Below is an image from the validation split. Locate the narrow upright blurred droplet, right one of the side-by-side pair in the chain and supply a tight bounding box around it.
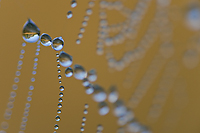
[108,86,119,103]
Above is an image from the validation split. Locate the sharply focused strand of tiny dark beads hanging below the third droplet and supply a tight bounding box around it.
[54,53,64,133]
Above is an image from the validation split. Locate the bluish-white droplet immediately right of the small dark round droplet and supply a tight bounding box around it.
[74,65,87,80]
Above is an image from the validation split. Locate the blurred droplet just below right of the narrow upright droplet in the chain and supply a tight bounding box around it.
[114,100,127,117]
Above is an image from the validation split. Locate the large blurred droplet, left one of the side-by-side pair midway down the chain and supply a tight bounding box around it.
[93,84,106,102]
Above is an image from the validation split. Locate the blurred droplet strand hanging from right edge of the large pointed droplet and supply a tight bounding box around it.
[19,41,40,133]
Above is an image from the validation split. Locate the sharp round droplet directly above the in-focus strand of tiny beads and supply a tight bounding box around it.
[51,37,64,51]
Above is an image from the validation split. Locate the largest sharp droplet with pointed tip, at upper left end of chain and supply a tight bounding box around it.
[22,19,40,43]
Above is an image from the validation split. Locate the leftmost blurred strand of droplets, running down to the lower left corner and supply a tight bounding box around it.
[0,43,26,133]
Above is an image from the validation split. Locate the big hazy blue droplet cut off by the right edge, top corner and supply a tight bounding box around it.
[185,2,200,30]
